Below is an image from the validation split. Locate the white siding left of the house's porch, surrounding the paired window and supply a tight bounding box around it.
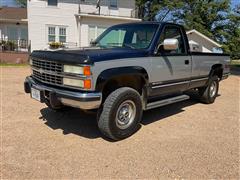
[28,0,79,50]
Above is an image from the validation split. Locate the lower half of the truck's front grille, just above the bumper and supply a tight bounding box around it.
[33,70,63,85]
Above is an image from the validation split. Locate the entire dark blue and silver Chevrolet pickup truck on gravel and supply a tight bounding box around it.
[24,22,230,140]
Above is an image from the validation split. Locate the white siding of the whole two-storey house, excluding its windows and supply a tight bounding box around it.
[28,0,138,50]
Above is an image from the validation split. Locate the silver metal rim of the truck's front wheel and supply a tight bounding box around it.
[116,100,136,129]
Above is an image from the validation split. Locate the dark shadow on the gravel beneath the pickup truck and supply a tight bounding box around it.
[39,92,203,141]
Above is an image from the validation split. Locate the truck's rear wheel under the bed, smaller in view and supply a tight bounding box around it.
[198,76,219,104]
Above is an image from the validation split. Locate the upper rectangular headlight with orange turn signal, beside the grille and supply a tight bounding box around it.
[63,65,91,76]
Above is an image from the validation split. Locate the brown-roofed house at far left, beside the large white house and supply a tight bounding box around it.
[0,7,28,49]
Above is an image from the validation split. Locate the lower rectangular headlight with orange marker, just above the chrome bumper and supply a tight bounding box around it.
[63,78,92,89]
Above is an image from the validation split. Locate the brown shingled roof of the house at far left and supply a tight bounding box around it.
[0,7,27,22]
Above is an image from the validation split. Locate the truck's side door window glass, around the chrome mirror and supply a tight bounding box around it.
[158,26,186,54]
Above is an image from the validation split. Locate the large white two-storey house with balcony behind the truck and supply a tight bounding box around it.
[28,0,140,50]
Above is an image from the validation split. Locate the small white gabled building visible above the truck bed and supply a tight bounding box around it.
[187,29,222,53]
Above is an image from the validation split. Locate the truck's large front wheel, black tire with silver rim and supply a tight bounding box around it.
[98,87,142,140]
